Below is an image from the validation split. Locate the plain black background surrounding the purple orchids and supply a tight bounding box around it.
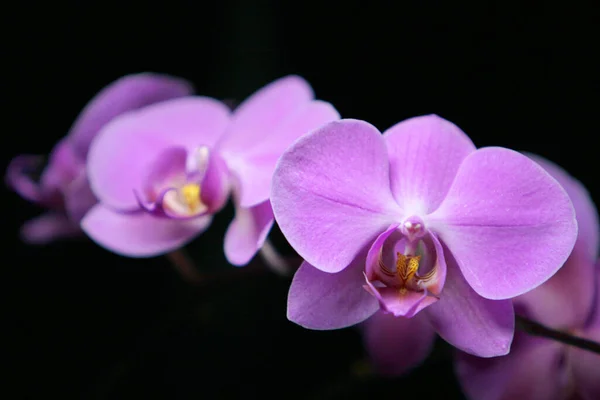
[0,0,600,399]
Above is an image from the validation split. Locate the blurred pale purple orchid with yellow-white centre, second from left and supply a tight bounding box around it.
[82,76,339,265]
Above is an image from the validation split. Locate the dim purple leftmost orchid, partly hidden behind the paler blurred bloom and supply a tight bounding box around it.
[6,73,193,244]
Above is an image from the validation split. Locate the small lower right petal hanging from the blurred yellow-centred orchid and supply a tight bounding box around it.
[225,201,273,266]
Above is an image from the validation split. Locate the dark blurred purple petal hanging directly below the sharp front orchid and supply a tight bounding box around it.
[361,311,435,376]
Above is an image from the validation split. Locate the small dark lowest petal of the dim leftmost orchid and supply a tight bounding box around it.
[21,212,82,245]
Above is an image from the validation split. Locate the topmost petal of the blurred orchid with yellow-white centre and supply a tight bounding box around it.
[218,75,314,154]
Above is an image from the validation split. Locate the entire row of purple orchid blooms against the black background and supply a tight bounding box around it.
[7,74,600,399]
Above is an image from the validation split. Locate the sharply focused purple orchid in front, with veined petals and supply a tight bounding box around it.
[271,116,577,357]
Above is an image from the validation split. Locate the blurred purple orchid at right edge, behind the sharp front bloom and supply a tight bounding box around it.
[456,156,600,400]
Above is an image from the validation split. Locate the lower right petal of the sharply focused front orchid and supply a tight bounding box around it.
[423,249,515,357]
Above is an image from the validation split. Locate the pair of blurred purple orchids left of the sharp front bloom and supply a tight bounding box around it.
[7,74,339,265]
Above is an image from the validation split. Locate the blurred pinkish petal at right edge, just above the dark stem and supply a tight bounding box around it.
[513,242,595,329]
